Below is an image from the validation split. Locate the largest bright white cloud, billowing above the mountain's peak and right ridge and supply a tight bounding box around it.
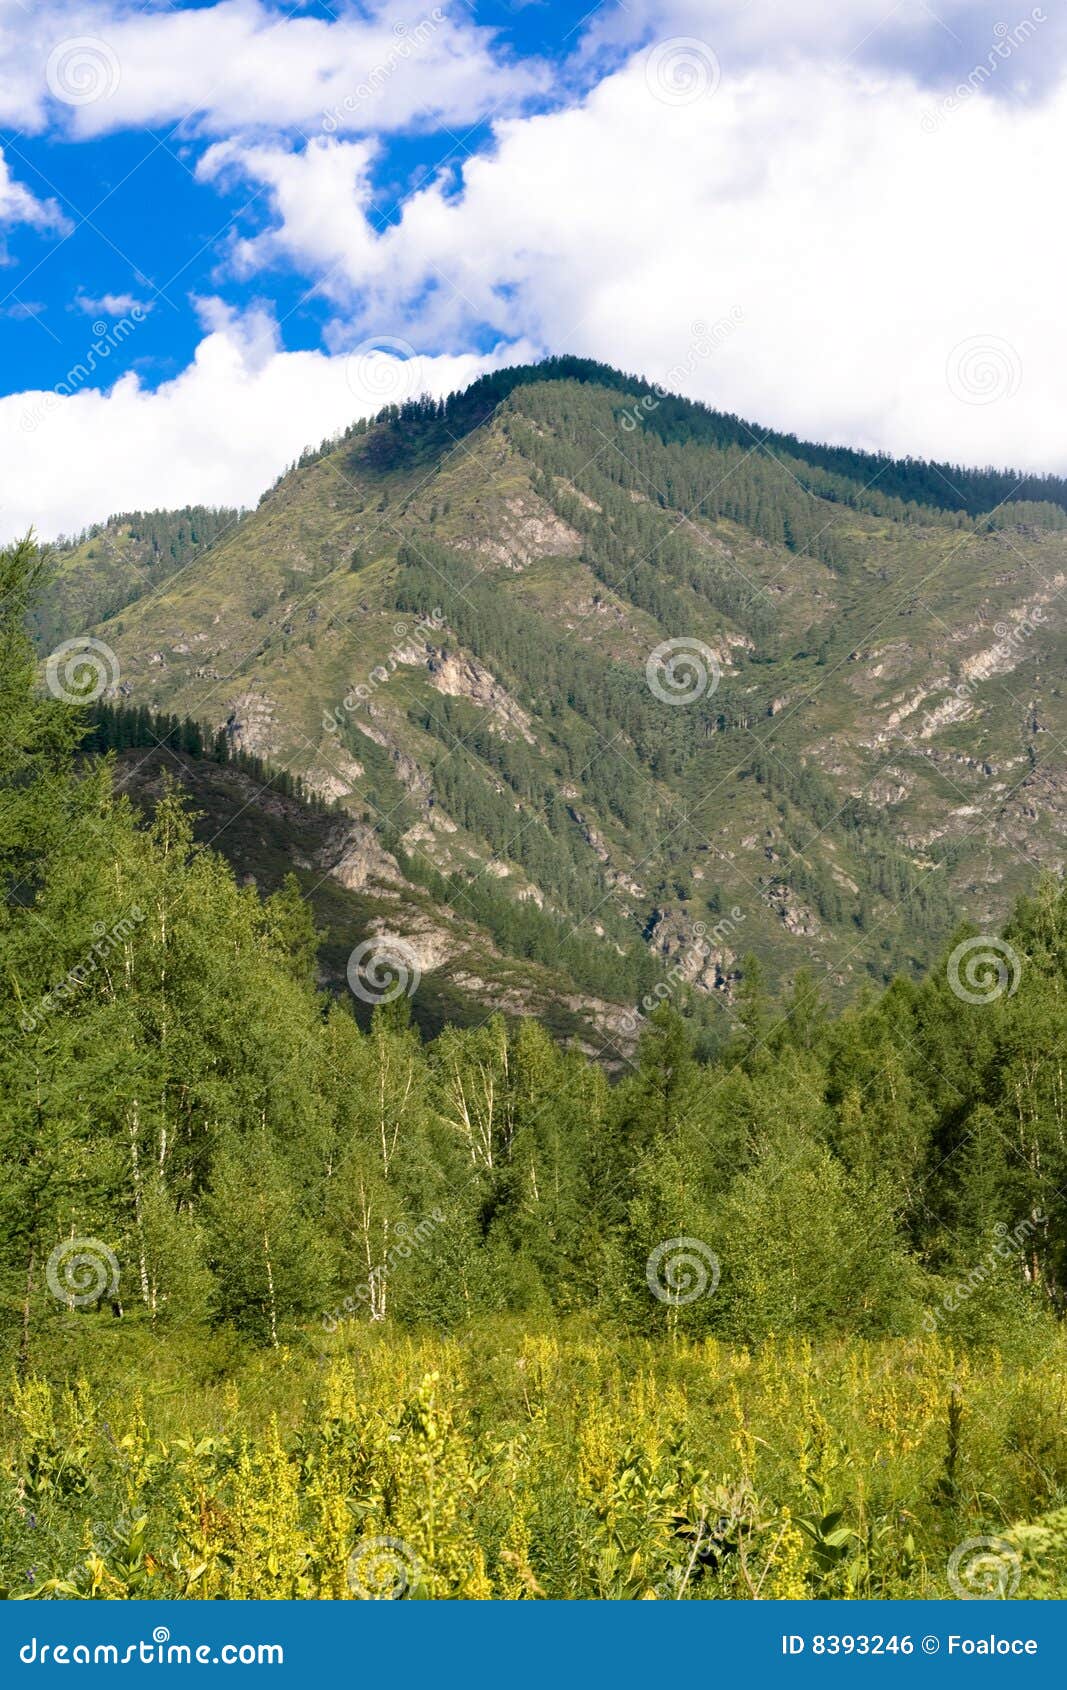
[203,42,1067,468]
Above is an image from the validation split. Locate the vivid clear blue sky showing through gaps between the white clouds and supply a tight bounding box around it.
[0,0,617,394]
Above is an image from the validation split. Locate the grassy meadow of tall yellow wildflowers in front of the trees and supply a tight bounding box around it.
[0,1317,1067,1600]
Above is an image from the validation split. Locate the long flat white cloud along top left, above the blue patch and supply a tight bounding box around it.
[0,0,548,137]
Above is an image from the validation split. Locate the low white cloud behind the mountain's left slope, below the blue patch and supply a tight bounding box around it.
[0,301,530,541]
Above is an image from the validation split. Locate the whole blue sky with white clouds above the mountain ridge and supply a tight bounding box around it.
[0,0,1067,536]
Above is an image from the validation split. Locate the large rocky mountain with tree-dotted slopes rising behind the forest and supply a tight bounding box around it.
[39,360,1067,1043]
